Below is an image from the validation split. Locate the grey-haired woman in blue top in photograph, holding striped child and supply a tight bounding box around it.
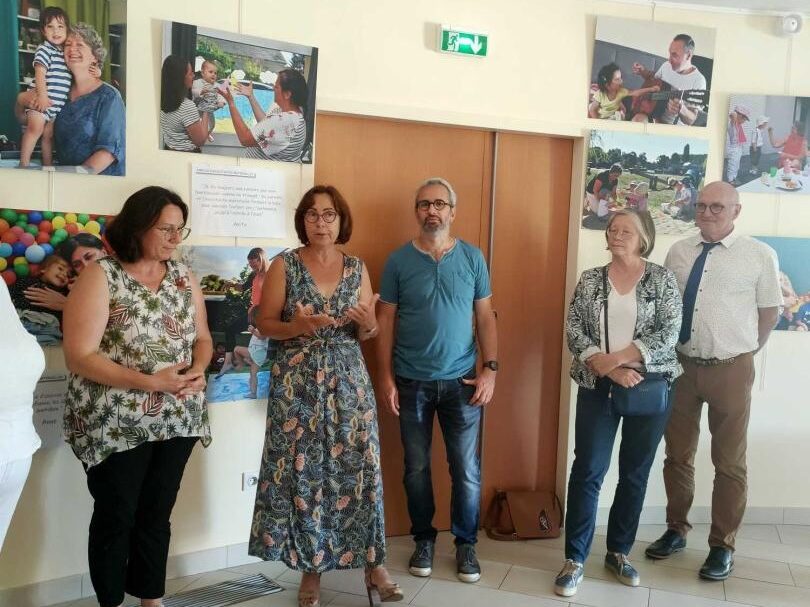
[53,23,126,175]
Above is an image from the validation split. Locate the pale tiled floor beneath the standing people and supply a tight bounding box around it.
[52,525,810,607]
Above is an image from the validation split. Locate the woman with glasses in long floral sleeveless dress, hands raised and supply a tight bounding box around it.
[250,186,403,607]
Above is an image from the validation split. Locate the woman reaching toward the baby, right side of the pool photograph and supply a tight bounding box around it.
[222,69,309,162]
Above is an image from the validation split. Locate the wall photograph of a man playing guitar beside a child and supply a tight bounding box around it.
[588,17,715,126]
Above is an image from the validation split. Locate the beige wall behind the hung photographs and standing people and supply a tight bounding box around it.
[0,0,810,588]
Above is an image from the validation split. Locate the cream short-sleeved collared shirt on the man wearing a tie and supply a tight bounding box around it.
[664,231,782,359]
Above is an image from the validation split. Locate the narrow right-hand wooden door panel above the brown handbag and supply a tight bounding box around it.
[482,133,573,505]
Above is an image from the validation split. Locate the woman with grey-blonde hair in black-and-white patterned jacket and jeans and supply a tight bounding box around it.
[554,209,682,596]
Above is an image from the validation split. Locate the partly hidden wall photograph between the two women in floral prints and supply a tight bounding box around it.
[180,245,284,403]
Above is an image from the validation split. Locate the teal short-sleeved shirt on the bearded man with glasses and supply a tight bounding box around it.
[380,239,492,381]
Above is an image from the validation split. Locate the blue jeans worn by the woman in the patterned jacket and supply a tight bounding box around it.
[565,379,672,563]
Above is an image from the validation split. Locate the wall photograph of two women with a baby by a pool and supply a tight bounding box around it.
[159,22,318,163]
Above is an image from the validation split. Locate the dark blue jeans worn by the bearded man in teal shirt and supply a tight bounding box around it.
[396,370,481,544]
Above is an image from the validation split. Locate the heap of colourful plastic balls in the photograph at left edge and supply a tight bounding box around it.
[0,209,112,287]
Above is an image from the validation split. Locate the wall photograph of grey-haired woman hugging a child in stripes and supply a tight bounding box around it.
[0,0,127,176]
